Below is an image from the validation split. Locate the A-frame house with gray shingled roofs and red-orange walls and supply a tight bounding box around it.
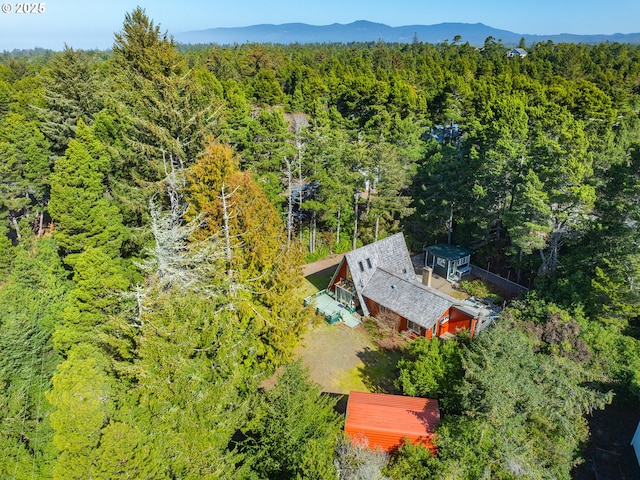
[327,233,479,338]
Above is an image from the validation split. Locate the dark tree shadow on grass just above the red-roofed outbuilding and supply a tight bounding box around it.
[357,347,402,394]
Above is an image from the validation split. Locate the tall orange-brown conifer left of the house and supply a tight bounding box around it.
[187,142,304,362]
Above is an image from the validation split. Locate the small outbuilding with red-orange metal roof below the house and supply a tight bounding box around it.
[344,392,440,452]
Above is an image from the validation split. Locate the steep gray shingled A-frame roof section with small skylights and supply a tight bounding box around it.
[344,233,415,315]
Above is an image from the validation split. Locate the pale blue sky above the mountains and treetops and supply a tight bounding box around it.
[0,0,640,51]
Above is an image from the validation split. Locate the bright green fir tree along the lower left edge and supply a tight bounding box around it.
[0,238,70,479]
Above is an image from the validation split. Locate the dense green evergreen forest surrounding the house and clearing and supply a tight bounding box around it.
[0,9,640,479]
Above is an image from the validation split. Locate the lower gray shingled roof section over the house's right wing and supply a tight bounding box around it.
[363,268,456,329]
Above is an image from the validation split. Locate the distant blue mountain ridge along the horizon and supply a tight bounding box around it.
[174,20,640,46]
